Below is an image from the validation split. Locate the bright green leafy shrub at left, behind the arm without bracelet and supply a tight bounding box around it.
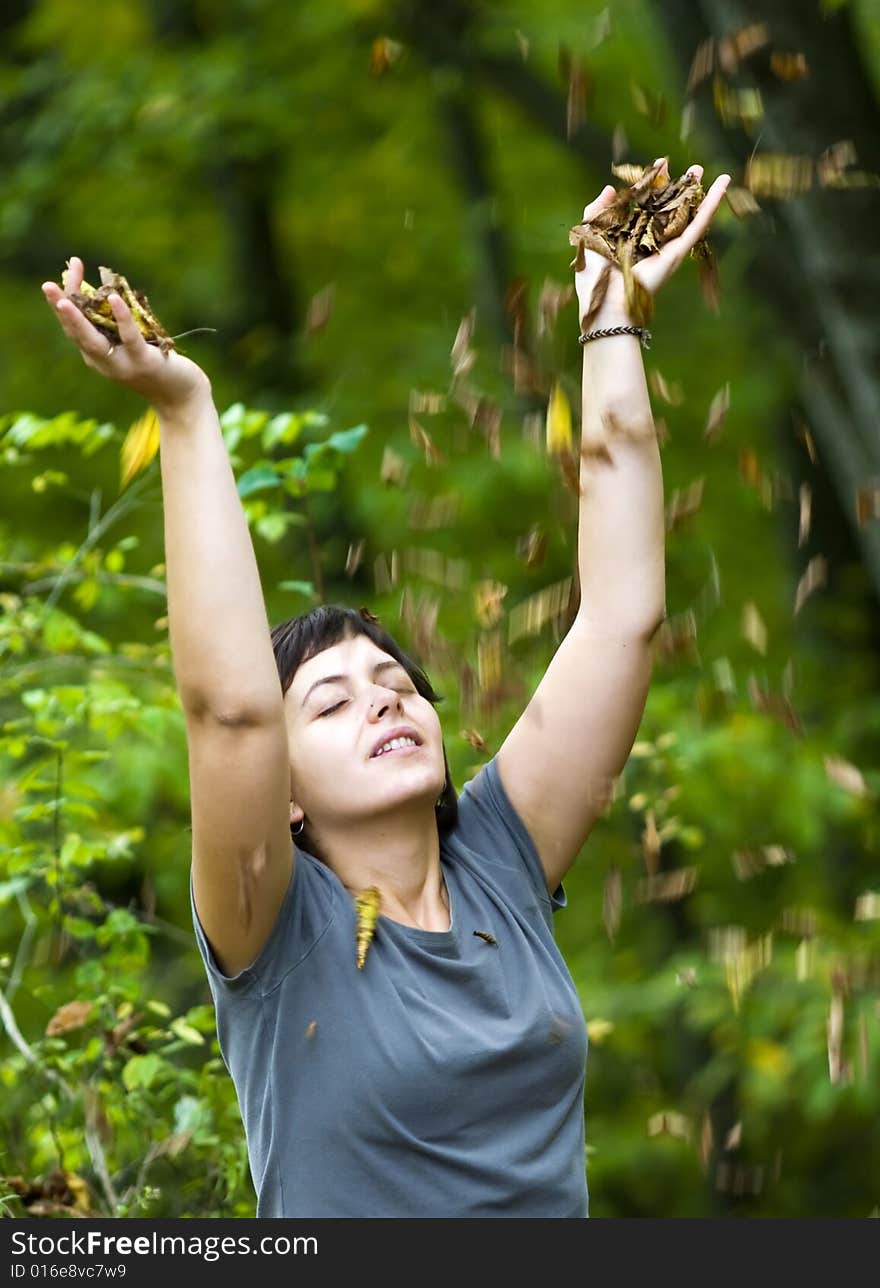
[0,404,367,1216]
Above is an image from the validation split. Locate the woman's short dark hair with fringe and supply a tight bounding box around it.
[272,604,459,858]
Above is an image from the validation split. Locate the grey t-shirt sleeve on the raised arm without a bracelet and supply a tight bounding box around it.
[189,842,334,993]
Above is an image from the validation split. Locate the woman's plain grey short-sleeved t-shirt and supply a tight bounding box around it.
[189,760,588,1217]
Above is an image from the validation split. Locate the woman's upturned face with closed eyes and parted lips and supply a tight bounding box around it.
[285,635,446,832]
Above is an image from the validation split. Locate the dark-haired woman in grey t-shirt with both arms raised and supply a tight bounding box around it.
[43,167,728,1217]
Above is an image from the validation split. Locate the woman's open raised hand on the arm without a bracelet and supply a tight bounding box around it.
[43,255,211,416]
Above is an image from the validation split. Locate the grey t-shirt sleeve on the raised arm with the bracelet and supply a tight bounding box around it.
[455,756,568,912]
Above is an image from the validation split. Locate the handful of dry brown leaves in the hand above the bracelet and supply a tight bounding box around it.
[568,157,718,326]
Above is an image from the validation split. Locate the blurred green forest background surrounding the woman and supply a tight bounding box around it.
[0,0,880,1217]
